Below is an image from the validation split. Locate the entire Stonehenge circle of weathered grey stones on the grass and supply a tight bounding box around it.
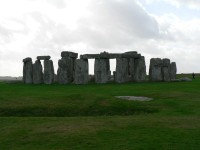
[23,51,177,84]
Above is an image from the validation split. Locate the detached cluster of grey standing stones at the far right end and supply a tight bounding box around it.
[149,58,177,81]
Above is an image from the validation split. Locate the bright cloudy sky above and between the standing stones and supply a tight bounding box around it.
[0,0,200,76]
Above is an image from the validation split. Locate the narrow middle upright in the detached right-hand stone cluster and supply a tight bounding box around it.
[162,58,170,81]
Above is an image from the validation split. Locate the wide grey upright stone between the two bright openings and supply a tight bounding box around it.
[94,59,111,83]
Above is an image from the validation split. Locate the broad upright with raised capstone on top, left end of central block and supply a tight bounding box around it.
[57,51,78,84]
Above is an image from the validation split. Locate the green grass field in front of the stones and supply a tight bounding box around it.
[0,77,200,150]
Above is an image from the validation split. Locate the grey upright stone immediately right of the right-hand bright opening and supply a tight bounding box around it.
[115,58,129,83]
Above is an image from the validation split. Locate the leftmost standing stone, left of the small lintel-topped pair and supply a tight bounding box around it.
[23,57,33,84]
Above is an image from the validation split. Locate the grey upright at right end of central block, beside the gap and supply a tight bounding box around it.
[134,56,146,82]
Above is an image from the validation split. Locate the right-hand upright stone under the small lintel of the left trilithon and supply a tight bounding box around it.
[43,60,54,84]
